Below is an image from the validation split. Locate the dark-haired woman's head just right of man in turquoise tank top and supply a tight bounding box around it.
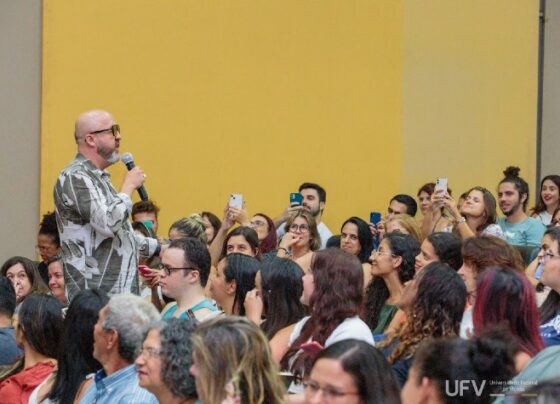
[209,253,261,316]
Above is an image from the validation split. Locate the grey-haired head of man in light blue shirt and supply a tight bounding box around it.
[93,294,160,365]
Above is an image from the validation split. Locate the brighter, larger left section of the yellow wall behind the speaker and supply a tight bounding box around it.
[41,0,403,231]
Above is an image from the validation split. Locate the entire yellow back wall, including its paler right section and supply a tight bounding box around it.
[41,0,538,232]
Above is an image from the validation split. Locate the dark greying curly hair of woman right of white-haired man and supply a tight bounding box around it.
[159,318,197,399]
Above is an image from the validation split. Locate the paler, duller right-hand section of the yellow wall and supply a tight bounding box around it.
[401,0,539,199]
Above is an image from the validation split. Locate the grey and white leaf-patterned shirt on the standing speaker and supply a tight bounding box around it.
[54,154,157,301]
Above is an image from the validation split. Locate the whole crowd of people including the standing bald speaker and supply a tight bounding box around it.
[0,111,560,404]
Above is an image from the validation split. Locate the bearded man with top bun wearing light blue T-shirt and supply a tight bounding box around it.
[498,167,546,247]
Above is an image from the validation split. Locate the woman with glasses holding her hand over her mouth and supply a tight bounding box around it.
[277,209,326,272]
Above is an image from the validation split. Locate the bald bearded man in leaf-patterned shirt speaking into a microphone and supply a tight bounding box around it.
[54,110,160,301]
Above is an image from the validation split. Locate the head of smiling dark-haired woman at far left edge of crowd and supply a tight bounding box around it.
[0,256,49,304]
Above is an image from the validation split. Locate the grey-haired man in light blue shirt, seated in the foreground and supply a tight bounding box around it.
[76,294,160,404]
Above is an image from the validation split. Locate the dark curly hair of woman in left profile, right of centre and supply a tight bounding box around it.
[363,233,420,330]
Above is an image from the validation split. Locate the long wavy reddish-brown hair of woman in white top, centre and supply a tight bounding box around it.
[281,248,364,376]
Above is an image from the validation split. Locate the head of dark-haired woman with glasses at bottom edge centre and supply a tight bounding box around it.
[305,339,400,404]
